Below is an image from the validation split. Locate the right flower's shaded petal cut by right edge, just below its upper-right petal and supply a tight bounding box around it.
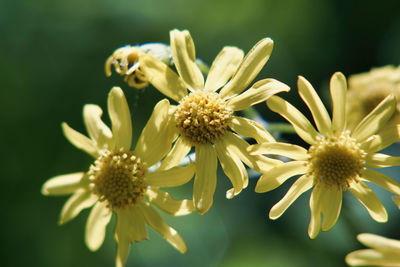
[361,125,400,152]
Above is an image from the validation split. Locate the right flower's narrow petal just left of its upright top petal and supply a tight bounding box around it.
[297,76,332,135]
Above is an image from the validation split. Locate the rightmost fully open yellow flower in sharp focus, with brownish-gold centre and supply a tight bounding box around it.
[249,73,400,238]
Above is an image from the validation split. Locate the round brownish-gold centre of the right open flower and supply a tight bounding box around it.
[308,132,366,190]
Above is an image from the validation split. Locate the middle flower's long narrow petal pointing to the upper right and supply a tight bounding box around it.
[220,38,274,98]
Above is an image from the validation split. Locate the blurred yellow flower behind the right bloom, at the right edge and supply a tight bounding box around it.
[346,65,400,131]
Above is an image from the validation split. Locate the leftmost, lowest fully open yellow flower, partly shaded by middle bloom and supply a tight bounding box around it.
[42,87,194,266]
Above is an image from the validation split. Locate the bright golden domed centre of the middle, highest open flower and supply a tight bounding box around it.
[175,90,233,144]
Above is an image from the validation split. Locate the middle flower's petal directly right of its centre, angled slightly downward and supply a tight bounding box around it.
[229,116,275,143]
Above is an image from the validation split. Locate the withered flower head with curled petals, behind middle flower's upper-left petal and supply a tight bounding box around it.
[105,43,171,89]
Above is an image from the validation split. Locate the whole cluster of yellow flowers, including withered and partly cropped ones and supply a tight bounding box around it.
[42,30,400,266]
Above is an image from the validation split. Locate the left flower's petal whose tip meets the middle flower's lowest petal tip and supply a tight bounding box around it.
[146,188,195,216]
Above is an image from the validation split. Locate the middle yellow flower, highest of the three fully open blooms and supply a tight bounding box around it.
[139,30,289,214]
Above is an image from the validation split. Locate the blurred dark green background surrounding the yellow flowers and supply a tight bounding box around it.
[0,0,400,267]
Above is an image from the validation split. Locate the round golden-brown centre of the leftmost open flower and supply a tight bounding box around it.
[89,149,147,210]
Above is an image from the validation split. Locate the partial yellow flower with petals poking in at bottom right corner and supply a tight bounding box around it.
[346,233,400,267]
